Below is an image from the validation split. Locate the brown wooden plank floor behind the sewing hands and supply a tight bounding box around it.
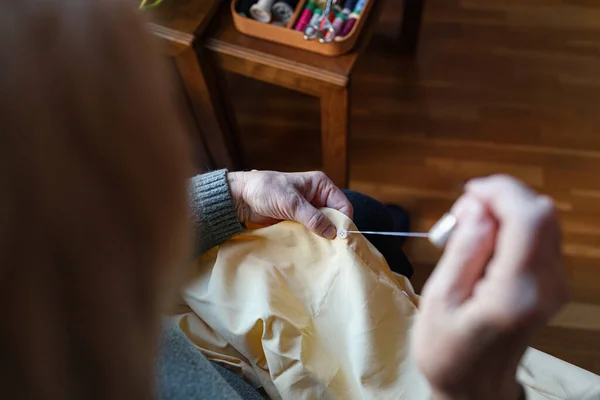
[225,0,600,374]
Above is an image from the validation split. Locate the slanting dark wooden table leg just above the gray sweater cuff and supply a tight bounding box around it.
[175,46,240,170]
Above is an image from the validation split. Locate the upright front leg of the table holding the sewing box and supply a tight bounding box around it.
[321,87,349,188]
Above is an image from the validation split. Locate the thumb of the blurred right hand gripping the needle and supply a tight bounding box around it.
[424,195,496,305]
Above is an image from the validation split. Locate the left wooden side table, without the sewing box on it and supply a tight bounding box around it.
[149,0,240,170]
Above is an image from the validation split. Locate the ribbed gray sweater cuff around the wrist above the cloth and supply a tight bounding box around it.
[189,169,243,255]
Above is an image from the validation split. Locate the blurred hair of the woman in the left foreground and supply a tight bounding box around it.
[0,0,191,399]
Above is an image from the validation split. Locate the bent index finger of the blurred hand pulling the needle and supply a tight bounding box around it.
[466,175,560,273]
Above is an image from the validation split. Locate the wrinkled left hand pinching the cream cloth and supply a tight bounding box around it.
[227,171,352,239]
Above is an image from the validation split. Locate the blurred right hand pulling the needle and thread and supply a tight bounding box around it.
[413,176,567,400]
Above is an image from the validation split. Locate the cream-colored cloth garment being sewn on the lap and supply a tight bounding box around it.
[174,210,600,400]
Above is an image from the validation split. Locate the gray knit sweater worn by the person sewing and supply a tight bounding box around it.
[157,170,262,400]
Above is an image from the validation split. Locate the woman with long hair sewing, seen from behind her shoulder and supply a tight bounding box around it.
[0,0,566,399]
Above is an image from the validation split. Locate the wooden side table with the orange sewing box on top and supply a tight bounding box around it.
[203,0,381,187]
